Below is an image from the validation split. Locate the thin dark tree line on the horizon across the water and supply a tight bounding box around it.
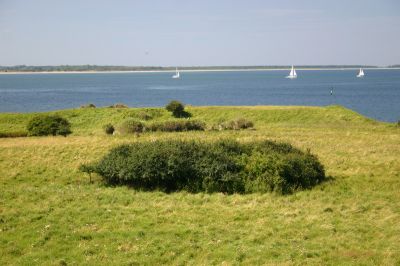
[0,65,388,72]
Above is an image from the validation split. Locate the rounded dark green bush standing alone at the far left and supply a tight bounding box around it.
[27,115,71,136]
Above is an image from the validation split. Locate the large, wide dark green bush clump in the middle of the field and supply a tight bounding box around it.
[81,140,325,194]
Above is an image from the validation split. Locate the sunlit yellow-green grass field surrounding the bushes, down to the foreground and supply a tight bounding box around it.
[0,106,400,265]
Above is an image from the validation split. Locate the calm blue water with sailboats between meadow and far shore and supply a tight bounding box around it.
[0,69,400,122]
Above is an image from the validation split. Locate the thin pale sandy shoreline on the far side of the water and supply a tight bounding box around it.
[0,67,400,75]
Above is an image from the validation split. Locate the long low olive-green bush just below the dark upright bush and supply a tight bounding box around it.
[146,120,205,132]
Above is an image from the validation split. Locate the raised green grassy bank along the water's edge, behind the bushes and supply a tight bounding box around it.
[0,106,384,136]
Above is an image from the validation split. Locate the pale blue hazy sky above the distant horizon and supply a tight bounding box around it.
[0,0,400,66]
